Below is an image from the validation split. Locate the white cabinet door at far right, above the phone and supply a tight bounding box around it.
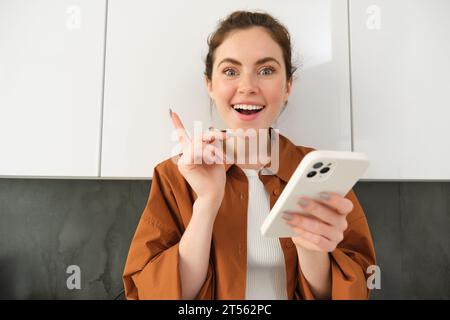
[350,0,450,180]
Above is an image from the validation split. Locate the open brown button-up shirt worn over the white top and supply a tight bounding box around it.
[123,134,375,300]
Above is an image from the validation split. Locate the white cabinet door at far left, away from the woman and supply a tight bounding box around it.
[0,0,106,177]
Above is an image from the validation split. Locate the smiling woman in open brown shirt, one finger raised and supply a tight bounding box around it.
[123,11,375,299]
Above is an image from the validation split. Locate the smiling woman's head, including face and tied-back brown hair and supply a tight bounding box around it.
[205,12,295,129]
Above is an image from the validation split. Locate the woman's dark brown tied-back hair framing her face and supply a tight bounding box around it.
[205,11,297,80]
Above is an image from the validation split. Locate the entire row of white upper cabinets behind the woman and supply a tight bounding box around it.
[0,0,450,180]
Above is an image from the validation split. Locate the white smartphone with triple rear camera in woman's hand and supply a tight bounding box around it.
[261,150,369,238]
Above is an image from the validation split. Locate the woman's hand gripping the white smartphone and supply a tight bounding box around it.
[283,192,353,252]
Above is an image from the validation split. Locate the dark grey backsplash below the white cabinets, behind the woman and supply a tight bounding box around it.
[0,179,450,299]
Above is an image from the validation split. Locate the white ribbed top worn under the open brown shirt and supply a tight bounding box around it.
[242,169,287,300]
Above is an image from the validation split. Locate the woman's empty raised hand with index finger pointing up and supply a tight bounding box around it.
[171,112,230,209]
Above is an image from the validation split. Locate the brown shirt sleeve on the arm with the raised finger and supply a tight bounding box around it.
[123,166,213,300]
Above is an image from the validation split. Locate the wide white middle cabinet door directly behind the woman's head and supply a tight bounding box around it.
[101,0,351,178]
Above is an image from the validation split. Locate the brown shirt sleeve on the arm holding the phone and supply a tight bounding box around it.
[299,190,376,300]
